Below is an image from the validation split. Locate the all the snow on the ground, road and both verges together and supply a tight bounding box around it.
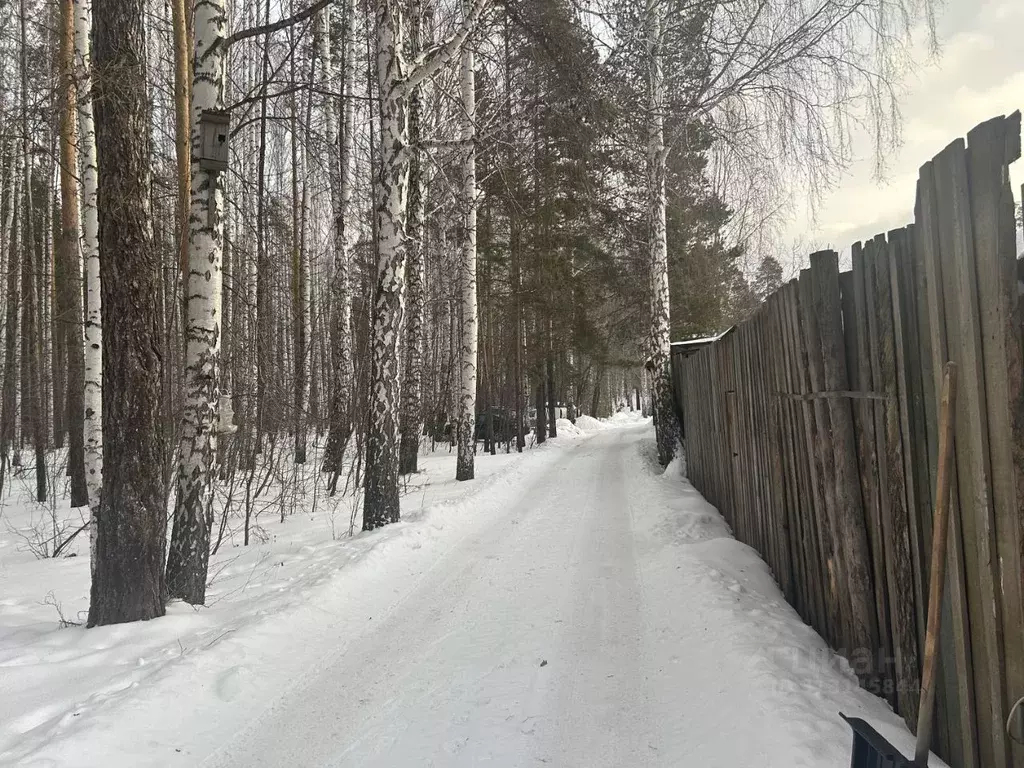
[0,415,934,768]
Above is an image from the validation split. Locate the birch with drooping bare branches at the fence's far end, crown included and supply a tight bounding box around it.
[597,0,933,464]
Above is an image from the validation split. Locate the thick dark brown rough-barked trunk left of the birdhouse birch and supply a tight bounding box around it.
[88,0,167,627]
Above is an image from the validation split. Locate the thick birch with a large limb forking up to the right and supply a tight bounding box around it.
[362,0,489,530]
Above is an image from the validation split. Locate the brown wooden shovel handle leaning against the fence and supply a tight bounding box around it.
[913,362,956,768]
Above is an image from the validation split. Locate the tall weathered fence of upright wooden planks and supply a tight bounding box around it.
[675,113,1024,768]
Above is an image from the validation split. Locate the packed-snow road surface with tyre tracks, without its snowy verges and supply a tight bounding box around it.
[209,423,675,768]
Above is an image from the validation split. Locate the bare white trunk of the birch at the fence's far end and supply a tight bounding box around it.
[647,0,679,466]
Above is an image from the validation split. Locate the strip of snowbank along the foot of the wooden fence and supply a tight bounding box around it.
[628,439,945,768]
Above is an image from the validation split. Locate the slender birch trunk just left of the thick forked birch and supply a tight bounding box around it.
[323,0,355,493]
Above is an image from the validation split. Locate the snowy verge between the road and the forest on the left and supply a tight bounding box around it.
[0,422,604,765]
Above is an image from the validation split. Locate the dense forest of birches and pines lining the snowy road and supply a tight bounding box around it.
[0,0,918,626]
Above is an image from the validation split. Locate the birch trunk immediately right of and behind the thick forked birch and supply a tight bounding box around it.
[398,0,430,474]
